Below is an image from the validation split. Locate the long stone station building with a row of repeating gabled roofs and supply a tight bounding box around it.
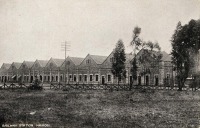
[0,50,175,85]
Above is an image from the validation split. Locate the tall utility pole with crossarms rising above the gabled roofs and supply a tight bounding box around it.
[61,41,70,86]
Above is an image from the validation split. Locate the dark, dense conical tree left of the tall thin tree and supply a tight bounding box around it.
[112,40,126,84]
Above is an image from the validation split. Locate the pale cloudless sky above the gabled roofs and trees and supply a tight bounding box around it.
[0,0,200,65]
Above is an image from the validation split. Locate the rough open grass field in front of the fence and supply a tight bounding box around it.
[0,89,200,128]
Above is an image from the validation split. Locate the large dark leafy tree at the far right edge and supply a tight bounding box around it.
[171,20,200,90]
